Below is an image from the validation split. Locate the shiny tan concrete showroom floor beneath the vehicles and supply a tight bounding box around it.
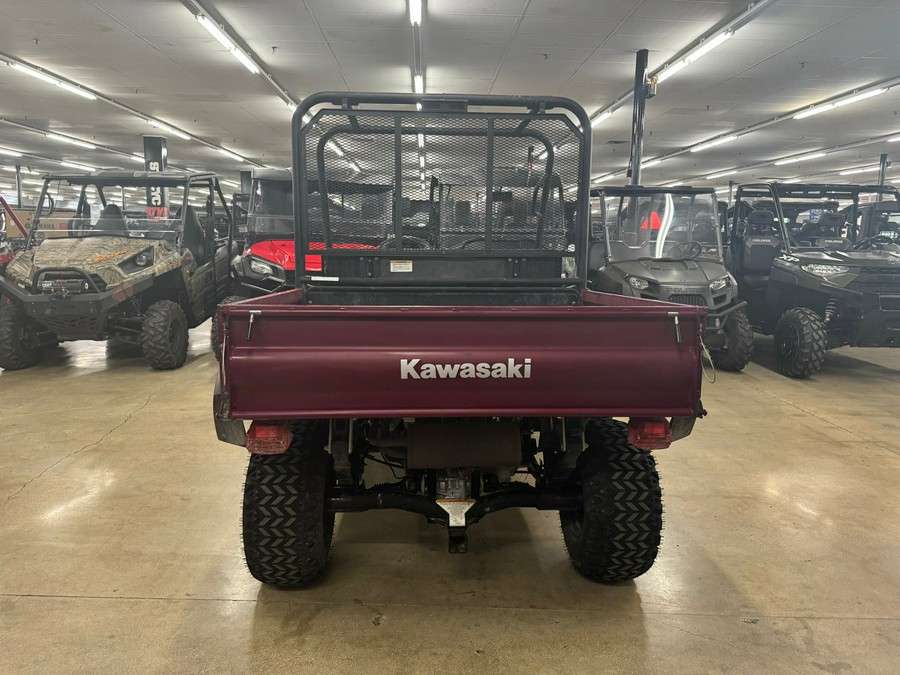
[0,326,900,673]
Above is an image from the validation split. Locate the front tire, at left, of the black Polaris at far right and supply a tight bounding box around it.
[775,307,827,379]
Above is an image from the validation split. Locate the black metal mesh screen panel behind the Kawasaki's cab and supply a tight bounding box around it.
[298,109,587,257]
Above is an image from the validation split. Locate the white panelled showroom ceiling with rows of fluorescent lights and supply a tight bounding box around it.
[0,0,900,195]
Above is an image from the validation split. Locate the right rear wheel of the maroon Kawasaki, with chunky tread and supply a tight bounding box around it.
[559,420,662,582]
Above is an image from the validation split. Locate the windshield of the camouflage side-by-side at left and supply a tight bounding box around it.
[32,179,220,243]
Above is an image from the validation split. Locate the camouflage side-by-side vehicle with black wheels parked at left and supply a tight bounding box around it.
[0,171,239,370]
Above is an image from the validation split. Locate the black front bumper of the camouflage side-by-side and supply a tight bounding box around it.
[0,277,153,341]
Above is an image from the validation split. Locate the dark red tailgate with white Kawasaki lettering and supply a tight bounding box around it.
[218,291,705,419]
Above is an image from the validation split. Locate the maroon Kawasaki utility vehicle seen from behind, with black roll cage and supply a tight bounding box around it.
[214,92,705,586]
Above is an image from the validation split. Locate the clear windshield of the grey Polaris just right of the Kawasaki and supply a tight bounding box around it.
[592,191,722,262]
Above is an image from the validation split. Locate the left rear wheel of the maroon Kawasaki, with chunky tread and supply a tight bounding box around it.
[243,423,334,586]
